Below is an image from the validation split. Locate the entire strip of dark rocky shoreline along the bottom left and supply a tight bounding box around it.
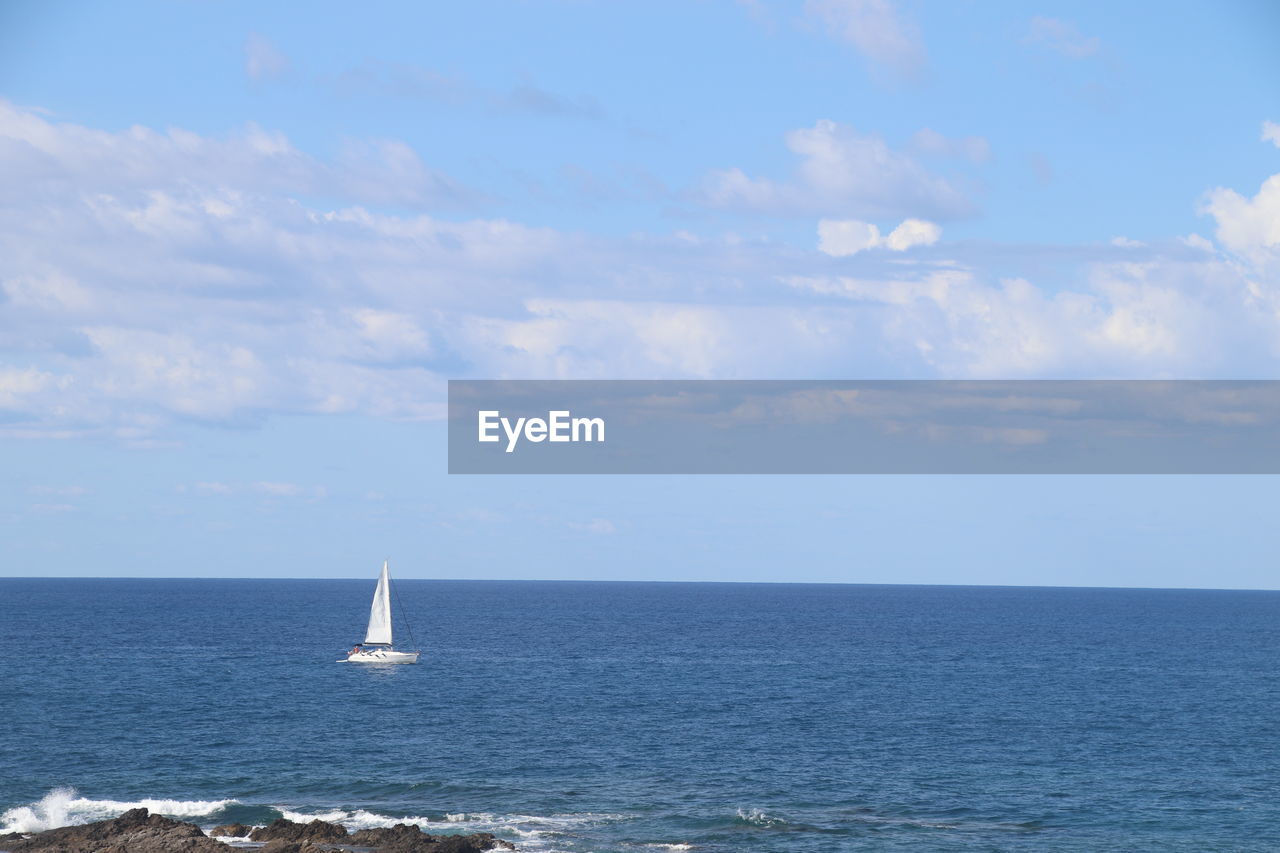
[0,808,516,853]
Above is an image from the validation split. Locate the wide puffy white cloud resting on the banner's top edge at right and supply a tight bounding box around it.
[787,233,1280,378]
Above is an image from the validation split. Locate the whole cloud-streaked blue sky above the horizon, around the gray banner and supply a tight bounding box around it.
[0,0,1280,588]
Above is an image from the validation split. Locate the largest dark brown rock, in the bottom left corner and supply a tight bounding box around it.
[5,808,228,853]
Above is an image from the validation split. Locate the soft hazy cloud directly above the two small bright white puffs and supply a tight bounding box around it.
[699,119,972,219]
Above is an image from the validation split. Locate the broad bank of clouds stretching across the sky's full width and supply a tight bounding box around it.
[0,104,1280,438]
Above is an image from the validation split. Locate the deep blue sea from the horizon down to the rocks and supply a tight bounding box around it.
[0,579,1280,853]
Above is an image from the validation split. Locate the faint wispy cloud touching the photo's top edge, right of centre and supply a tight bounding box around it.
[805,0,925,79]
